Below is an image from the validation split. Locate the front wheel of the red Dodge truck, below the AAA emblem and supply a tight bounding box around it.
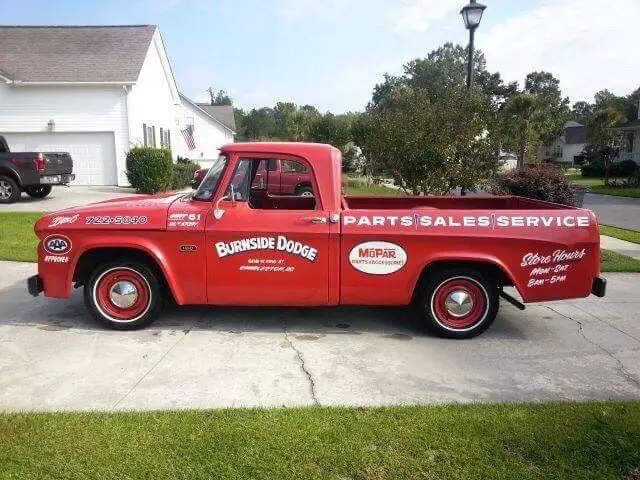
[84,261,162,330]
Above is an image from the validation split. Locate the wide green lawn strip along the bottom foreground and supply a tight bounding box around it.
[0,402,640,480]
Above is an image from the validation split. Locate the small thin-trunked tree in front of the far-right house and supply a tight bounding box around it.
[589,106,624,185]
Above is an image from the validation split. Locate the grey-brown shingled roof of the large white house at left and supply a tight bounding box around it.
[0,25,157,84]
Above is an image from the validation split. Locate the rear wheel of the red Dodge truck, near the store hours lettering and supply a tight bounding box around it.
[420,268,500,338]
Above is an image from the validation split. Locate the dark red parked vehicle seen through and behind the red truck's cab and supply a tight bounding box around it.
[191,159,313,197]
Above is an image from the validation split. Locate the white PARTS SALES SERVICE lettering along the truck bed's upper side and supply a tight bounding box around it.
[342,213,591,228]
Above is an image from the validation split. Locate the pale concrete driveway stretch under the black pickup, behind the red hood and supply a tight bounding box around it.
[0,186,135,212]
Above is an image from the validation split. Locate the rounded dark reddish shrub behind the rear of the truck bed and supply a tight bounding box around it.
[492,165,575,205]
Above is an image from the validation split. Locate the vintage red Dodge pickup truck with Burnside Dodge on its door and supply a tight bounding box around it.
[28,143,606,338]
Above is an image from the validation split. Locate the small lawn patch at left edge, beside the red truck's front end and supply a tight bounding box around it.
[0,212,42,262]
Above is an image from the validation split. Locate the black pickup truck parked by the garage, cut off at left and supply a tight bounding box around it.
[0,135,76,203]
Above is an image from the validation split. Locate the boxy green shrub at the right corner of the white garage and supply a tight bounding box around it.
[127,147,173,193]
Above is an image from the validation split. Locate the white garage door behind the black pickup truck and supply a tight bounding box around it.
[3,132,118,185]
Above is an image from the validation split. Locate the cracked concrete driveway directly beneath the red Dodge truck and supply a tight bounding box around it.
[0,262,640,410]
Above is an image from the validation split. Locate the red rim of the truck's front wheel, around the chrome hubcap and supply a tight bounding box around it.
[94,268,151,322]
